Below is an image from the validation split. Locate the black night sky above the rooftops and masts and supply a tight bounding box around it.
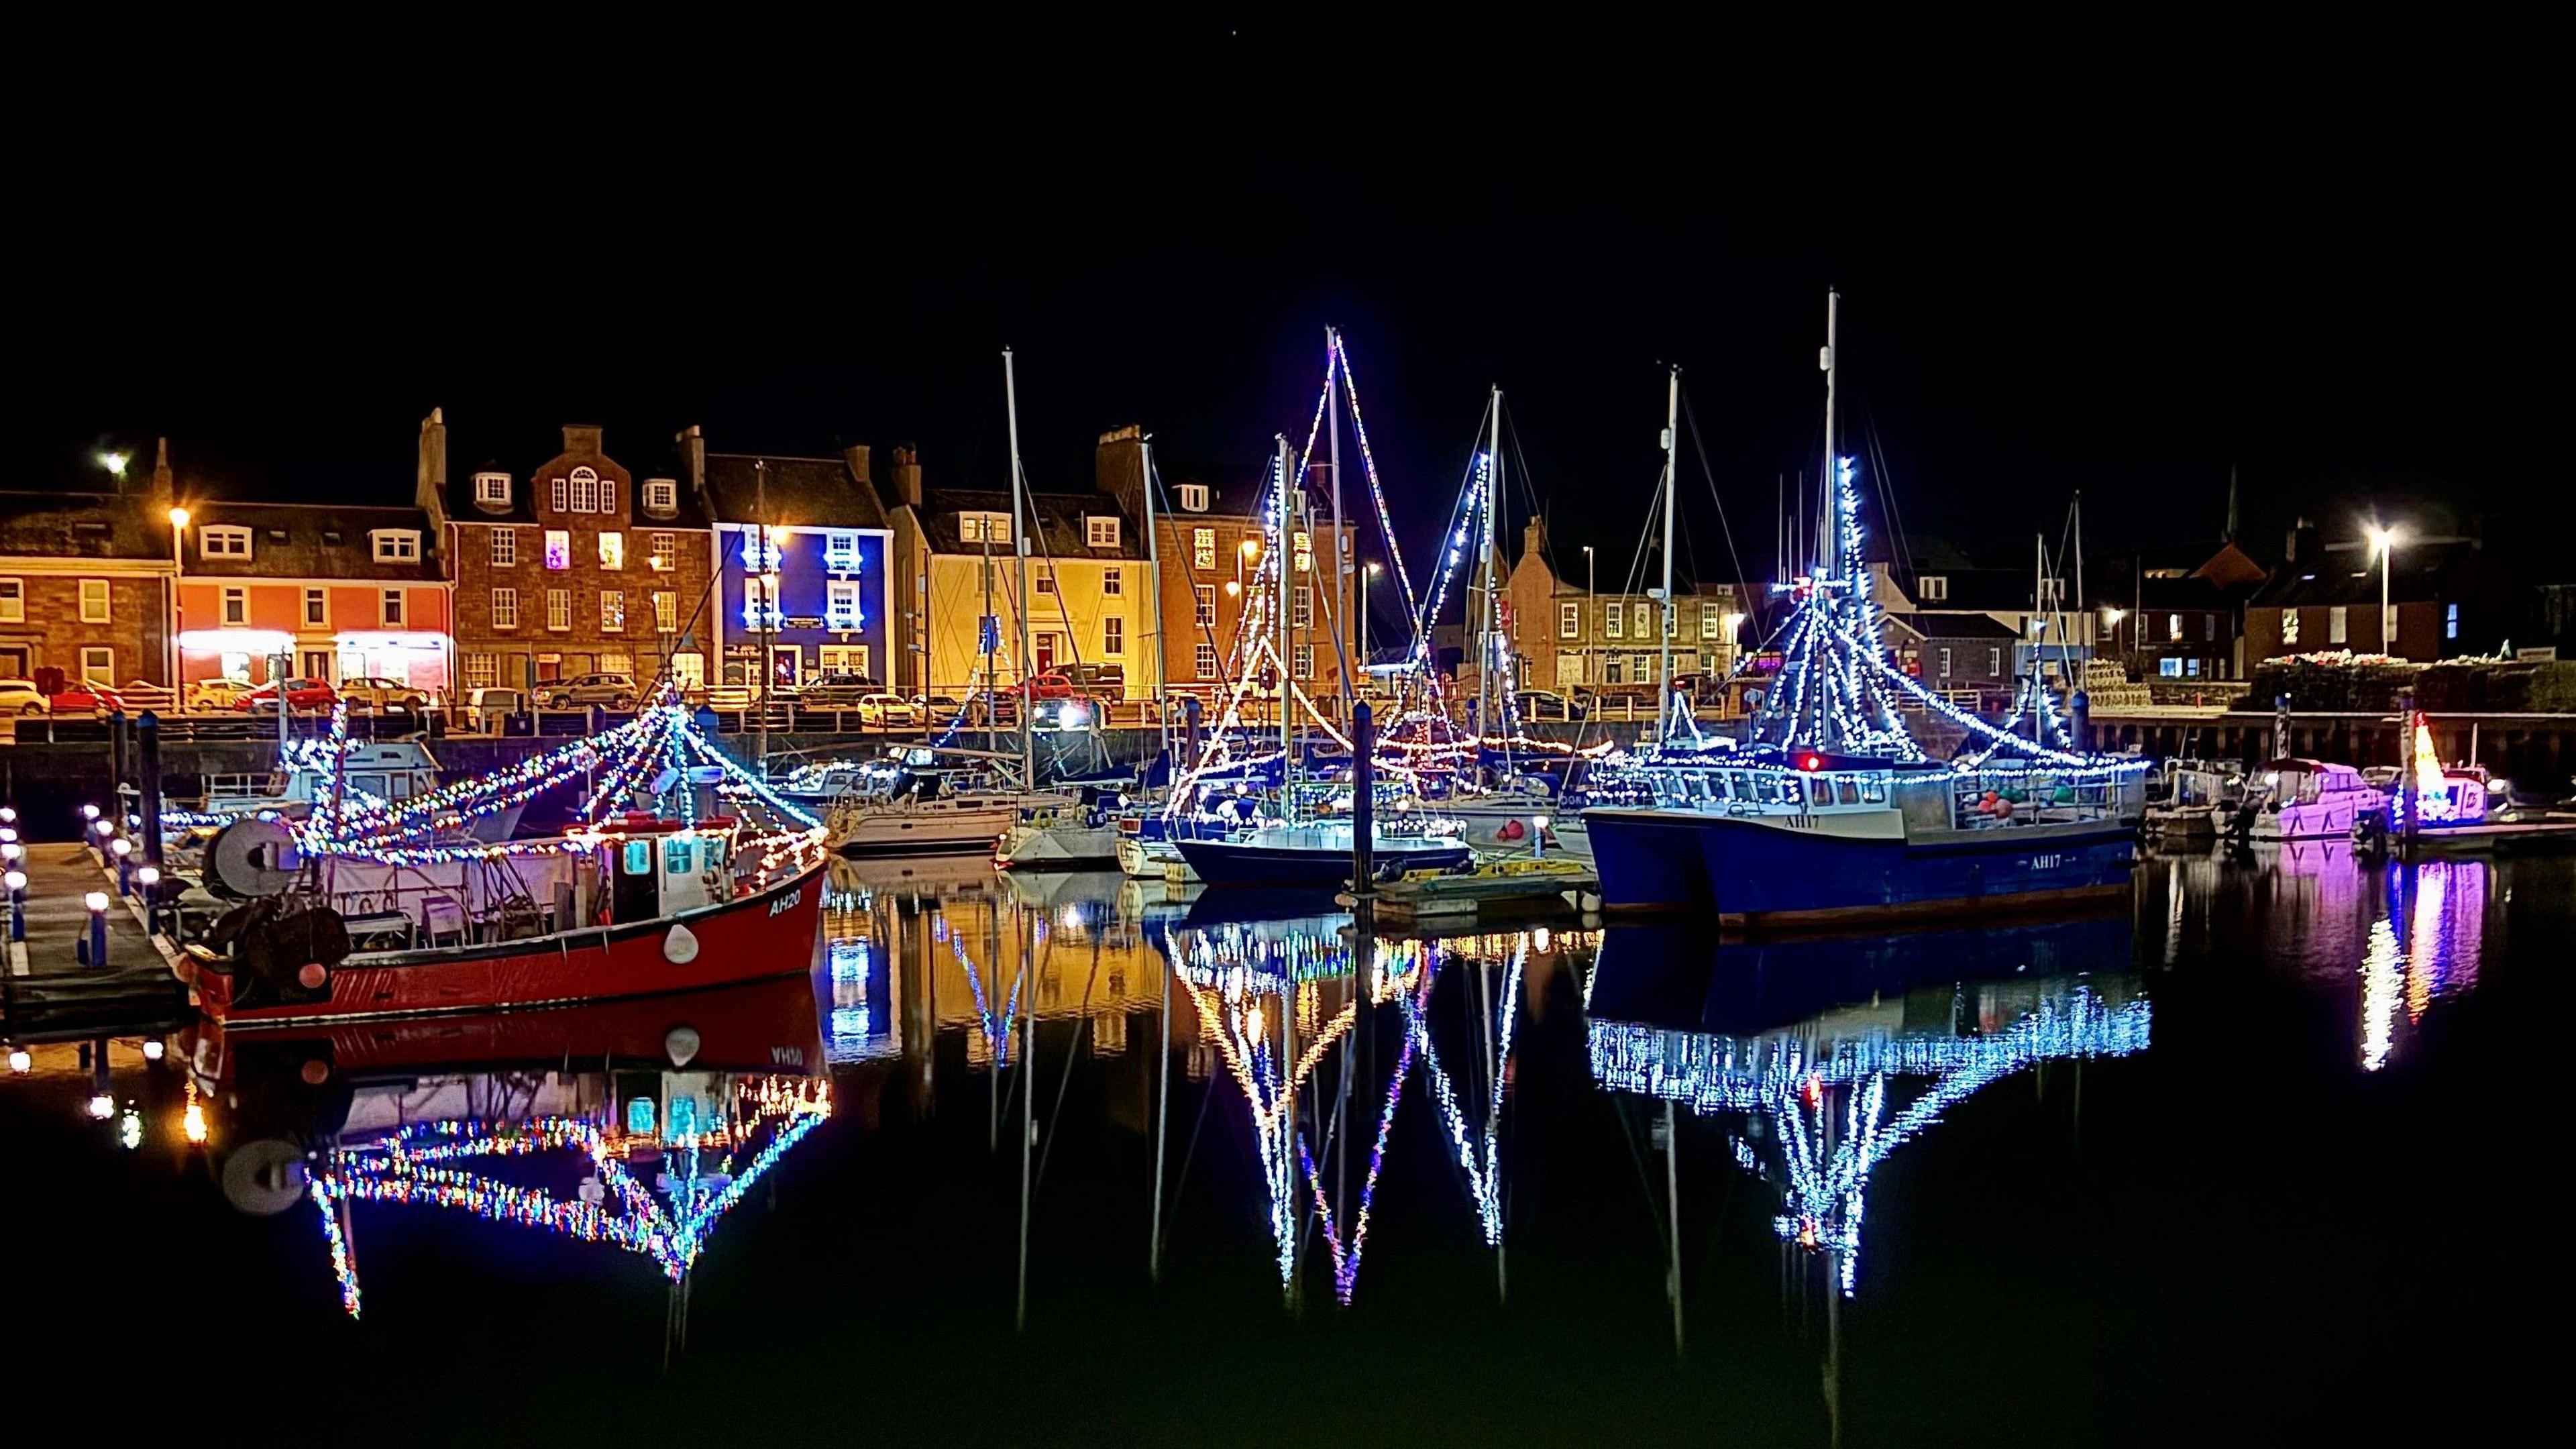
[25,34,2576,585]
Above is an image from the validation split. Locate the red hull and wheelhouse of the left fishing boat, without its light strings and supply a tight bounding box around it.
[178,822,824,1029]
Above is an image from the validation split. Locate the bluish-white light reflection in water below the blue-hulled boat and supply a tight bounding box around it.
[1589,982,2151,1297]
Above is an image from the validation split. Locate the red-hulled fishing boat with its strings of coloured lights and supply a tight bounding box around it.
[175,709,824,1031]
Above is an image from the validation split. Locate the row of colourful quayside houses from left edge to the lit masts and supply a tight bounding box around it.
[0,413,1355,699]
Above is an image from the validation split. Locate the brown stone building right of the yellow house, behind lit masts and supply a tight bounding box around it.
[1092,428,1386,704]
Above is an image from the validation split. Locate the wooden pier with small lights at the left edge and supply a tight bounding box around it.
[0,843,188,1042]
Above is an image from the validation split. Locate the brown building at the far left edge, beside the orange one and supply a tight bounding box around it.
[0,443,175,686]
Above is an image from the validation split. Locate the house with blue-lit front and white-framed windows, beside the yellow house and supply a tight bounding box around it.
[680,431,894,688]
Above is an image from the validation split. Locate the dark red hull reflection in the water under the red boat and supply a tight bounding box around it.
[191,977,824,1080]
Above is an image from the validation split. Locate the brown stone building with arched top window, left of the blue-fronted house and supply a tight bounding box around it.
[417,413,714,696]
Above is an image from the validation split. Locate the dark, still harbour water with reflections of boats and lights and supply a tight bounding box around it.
[0,848,2576,1444]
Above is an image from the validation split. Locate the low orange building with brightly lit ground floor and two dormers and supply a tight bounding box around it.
[178,502,453,696]
